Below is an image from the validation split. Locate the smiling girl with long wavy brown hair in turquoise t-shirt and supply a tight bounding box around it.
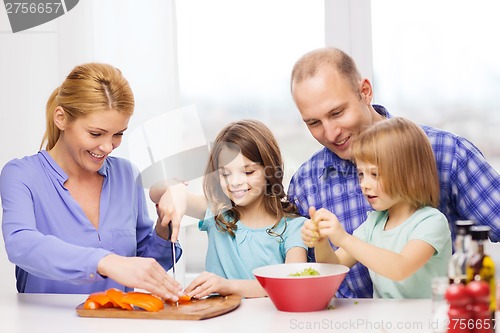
[150,120,307,298]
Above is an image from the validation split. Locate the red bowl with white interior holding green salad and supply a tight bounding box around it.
[253,263,349,312]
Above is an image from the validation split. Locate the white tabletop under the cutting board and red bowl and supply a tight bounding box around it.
[0,293,500,333]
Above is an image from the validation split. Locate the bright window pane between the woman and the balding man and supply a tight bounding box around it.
[176,0,324,179]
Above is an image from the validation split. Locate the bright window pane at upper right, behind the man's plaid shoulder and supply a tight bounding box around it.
[371,0,500,170]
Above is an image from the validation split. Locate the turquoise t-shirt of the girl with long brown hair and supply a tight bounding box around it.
[199,210,307,280]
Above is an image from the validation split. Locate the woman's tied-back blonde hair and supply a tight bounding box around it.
[40,63,134,150]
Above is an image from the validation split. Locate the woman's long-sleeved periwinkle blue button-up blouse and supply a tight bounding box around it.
[0,151,180,294]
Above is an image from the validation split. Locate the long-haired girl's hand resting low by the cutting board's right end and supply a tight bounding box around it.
[185,272,233,298]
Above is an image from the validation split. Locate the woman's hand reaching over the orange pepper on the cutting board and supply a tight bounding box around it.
[97,254,183,302]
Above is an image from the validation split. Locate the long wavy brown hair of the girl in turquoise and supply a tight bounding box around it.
[203,120,297,236]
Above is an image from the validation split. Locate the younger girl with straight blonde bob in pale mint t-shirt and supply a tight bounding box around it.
[302,117,451,298]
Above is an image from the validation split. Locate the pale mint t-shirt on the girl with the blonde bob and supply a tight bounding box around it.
[353,207,451,298]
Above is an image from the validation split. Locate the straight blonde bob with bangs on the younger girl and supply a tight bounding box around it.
[351,117,439,208]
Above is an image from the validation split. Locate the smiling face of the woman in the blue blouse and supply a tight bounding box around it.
[56,110,130,172]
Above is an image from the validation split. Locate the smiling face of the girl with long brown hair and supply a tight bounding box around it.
[218,148,266,206]
